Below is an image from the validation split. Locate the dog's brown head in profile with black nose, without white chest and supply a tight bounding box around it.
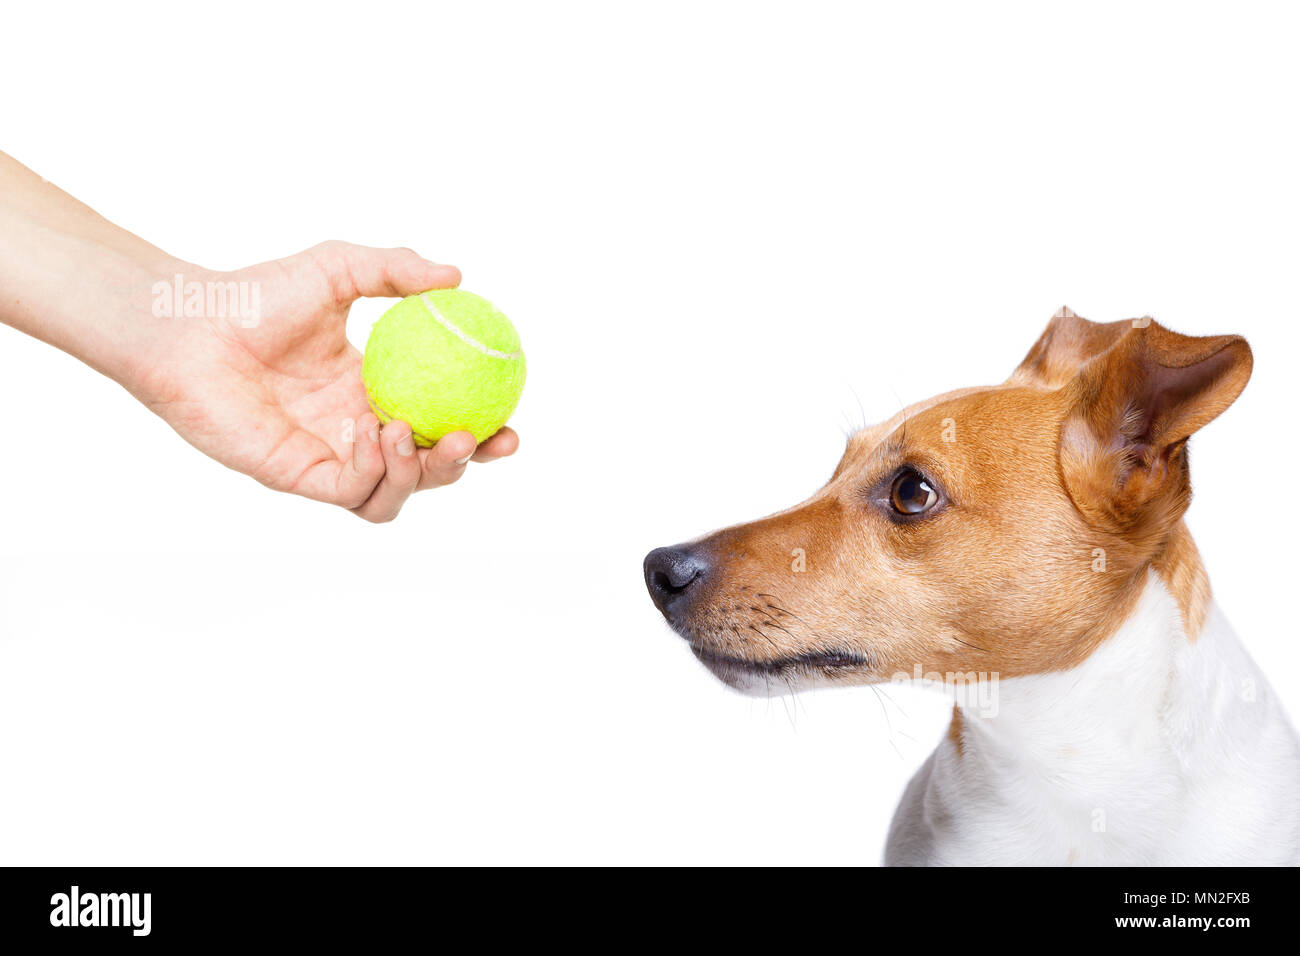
[645,310,1252,693]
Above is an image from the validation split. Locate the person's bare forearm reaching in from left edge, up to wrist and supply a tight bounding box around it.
[0,153,192,388]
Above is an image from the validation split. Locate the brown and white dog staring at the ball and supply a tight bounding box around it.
[644,308,1300,865]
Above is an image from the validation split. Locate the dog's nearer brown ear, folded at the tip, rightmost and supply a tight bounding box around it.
[1060,319,1252,531]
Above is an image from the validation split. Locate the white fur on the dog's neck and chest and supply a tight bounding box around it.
[885,575,1300,865]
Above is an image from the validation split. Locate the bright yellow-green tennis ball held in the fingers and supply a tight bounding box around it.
[361,289,525,447]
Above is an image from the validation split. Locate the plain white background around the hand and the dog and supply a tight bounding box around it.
[0,1,1300,864]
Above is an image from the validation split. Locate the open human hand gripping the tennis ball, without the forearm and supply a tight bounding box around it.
[124,242,519,522]
